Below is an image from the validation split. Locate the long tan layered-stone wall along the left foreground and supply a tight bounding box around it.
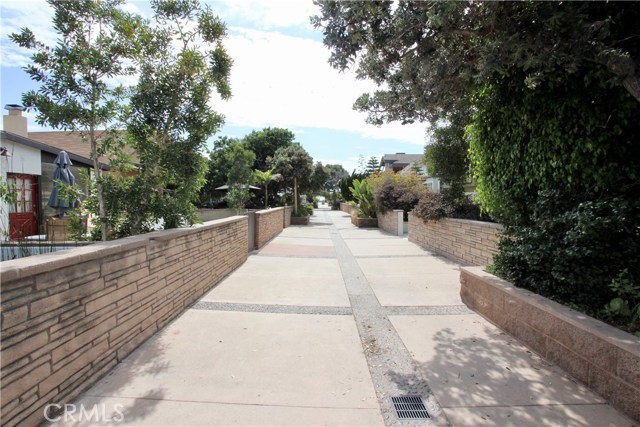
[0,217,247,426]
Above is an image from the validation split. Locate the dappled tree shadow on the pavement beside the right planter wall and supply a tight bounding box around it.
[389,324,633,426]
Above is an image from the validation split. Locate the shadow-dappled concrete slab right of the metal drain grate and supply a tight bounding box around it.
[390,314,604,412]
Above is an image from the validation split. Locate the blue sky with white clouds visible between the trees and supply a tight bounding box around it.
[0,0,426,172]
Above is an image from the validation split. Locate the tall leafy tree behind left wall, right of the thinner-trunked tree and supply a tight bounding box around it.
[127,0,232,230]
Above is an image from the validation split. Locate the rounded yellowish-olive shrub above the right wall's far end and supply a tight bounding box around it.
[367,170,427,217]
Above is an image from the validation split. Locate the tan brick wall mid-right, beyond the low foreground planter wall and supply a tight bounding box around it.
[409,216,502,265]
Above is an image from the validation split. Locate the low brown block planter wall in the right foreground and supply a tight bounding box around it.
[460,267,640,421]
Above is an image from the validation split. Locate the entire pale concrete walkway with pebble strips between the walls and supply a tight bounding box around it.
[59,209,633,426]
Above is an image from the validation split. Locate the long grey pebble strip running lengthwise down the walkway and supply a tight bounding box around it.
[324,212,450,426]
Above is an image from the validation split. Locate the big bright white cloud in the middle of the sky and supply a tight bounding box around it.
[215,27,425,146]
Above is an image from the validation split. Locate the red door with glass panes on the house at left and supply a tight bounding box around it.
[7,174,38,240]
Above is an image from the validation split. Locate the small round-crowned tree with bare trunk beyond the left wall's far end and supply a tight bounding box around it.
[267,143,313,211]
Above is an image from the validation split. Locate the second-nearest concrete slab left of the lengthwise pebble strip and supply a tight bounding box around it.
[201,255,350,307]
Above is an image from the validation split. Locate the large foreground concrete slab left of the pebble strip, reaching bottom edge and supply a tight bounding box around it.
[65,309,383,425]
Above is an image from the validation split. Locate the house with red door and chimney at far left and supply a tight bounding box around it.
[0,104,109,240]
